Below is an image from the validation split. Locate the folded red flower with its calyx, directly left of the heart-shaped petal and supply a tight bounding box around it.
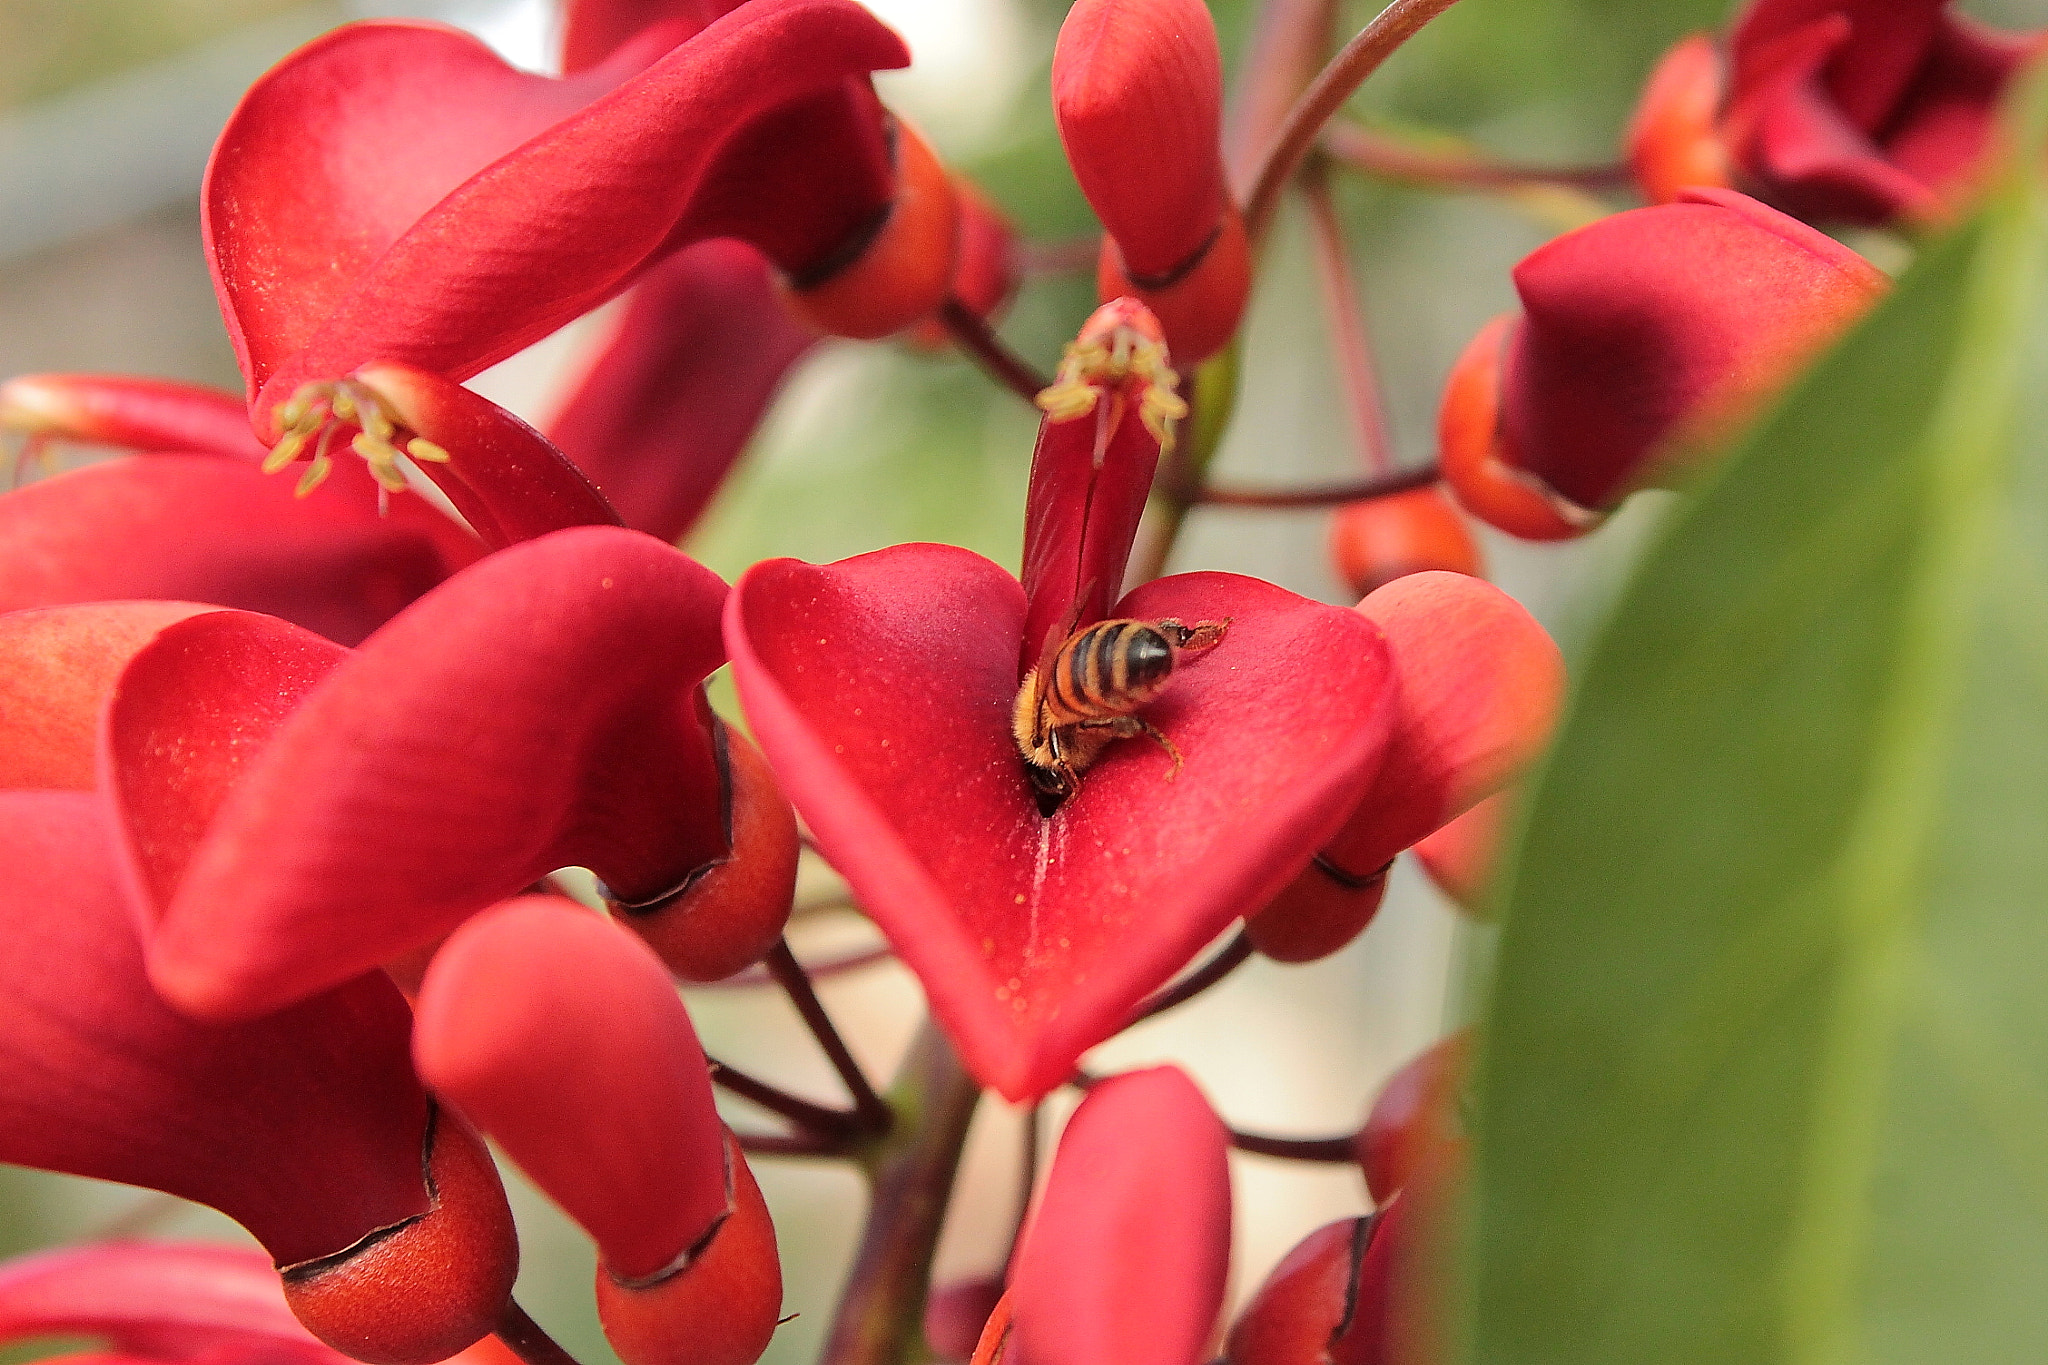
[102,526,795,1019]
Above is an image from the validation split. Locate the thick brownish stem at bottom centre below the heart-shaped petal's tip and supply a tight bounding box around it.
[819,1019,981,1365]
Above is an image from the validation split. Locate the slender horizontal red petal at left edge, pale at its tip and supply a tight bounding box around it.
[0,375,264,463]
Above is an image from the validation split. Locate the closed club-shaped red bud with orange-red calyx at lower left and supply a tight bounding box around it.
[414,896,782,1365]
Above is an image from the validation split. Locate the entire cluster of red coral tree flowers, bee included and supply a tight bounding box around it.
[0,0,1982,1365]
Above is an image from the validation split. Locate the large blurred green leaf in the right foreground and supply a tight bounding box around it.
[1468,90,2048,1365]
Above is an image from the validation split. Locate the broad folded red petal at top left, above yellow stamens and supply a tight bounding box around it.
[205,0,907,417]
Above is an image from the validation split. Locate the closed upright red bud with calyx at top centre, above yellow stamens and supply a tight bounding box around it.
[1053,0,1251,364]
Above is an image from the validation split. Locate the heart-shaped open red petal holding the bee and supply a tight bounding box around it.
[725,544,1391,1099]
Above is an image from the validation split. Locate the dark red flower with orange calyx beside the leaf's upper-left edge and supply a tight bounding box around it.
[1440,190,1886,536]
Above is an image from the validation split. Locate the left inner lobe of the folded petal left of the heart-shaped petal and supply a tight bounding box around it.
[98,612,348,923]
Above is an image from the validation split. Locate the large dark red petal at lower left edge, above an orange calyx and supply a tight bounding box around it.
[0,792,428,1265]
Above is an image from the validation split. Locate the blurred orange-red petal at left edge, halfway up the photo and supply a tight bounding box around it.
[0,602,213,792]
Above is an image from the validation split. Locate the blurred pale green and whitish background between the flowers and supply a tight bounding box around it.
[0,0,2048,1363]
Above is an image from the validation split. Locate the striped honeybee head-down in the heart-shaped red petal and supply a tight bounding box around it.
[1010,618,1231,798]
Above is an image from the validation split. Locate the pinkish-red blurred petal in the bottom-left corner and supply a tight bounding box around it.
[0,1242,348,1365]
